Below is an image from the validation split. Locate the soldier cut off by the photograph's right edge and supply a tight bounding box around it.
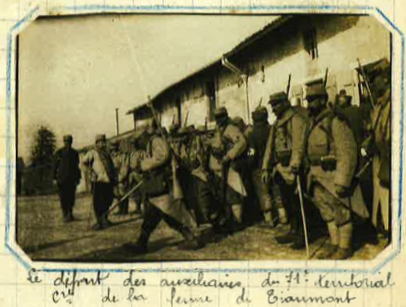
[363,65,391,240]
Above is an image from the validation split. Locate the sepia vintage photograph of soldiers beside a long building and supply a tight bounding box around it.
[16,14,392,263]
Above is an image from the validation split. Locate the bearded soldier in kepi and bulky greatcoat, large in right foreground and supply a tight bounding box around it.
[306,85,368,260]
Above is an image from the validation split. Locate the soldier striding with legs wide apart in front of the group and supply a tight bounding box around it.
[125,120,201,254]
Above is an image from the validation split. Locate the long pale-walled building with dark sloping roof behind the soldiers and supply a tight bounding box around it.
[127,14,391,129]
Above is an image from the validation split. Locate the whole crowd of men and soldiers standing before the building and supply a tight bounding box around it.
[55,61,391,260]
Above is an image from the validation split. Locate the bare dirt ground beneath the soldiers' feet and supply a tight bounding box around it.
[17,195,386,262]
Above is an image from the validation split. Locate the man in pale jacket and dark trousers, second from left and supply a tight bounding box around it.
[83,134,116,230]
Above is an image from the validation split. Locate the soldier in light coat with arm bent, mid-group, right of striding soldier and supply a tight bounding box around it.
[209,107,247,228]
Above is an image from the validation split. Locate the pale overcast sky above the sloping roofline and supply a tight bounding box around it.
[19,15,275,159]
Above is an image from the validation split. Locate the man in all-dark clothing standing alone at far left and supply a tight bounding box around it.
[54,135,81,222]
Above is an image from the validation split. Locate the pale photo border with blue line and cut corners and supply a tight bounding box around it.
[5,5,405,274]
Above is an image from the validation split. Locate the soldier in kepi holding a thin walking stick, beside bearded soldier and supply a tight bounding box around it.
[262,92,308,249]
